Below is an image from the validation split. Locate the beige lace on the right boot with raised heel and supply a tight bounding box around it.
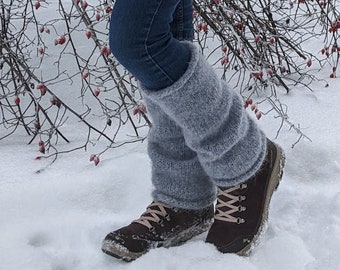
[215,184,247,224]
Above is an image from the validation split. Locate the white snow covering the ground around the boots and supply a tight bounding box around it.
[0,1,340,270]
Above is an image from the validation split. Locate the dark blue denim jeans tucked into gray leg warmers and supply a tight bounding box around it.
[110,0,193,90]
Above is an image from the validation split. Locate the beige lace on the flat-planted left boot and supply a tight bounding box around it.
[133,202,170,231]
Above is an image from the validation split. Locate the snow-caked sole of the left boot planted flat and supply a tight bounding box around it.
[102,218,213,262]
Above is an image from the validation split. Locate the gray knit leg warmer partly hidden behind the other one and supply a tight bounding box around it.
[145,98,216,209]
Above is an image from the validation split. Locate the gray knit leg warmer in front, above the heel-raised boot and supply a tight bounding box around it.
[142,42,266,188]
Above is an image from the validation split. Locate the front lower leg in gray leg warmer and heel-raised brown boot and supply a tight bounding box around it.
[142,42,284,255]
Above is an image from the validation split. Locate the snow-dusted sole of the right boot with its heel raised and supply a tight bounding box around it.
[236,143,286,256]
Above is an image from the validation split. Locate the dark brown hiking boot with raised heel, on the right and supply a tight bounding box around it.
[206,140,285,255]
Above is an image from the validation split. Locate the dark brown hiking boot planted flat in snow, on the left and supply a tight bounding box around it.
[102,202,214,261]
